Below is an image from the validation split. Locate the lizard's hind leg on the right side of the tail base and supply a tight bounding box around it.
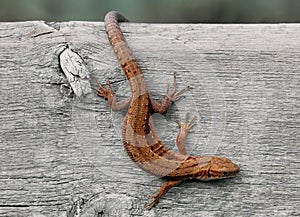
[151,72,186,114]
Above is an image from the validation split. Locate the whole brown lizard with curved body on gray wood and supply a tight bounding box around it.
[97,11,240,209]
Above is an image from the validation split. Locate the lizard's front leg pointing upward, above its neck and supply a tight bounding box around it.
[176,114,195,155]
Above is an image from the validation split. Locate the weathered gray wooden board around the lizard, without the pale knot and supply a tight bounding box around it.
[0,21,300,216]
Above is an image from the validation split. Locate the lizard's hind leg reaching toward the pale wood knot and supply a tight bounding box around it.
[94,78,131,111]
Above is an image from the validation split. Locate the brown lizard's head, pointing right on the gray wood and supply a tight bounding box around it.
[196,156,240,180]
